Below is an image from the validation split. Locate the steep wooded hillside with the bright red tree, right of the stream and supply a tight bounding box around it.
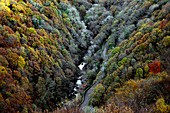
[75,0,170,113]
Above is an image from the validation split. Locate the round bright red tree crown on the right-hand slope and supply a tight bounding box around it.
[149,60,161,74]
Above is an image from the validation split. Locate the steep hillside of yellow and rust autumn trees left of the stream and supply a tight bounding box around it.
[0,0,91,113]
